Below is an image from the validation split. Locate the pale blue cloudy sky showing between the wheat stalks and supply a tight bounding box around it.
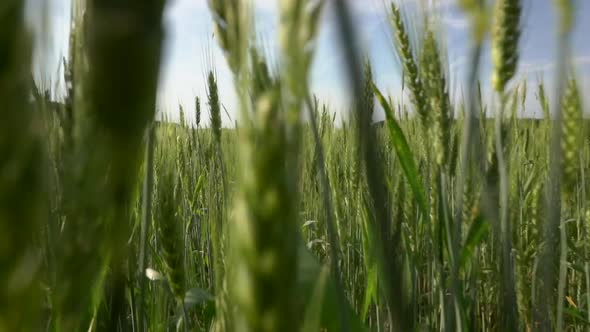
[29,0,590,125]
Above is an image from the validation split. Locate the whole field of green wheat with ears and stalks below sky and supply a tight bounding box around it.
[0,0,590,332]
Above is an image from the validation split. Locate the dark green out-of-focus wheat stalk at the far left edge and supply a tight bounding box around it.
[0,0,47,331]
